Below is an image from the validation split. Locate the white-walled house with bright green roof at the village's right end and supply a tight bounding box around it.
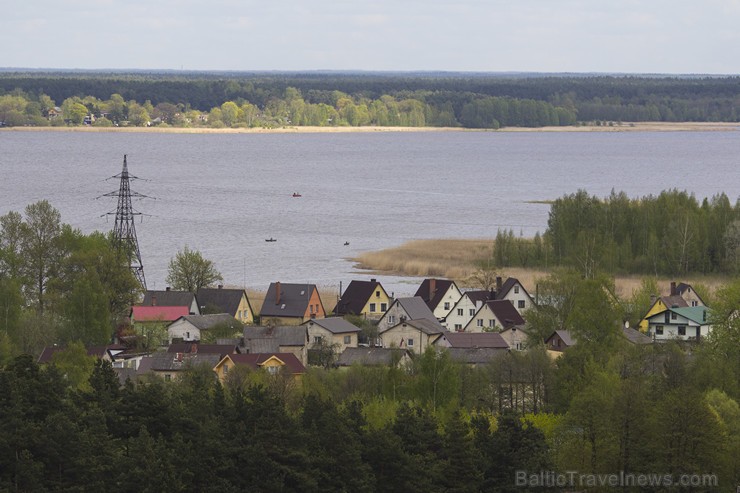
[647,306,712,342]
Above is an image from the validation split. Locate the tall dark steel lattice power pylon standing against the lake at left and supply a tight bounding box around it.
[102,154,149,290]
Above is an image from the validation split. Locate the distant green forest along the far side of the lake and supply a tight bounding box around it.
[0,71,740,129]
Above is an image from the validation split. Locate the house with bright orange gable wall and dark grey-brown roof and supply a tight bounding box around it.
[260,282,326,325]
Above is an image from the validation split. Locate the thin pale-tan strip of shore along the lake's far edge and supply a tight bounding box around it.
[0,122,740,134]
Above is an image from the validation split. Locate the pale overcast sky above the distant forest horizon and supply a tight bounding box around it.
[0,0,740,75]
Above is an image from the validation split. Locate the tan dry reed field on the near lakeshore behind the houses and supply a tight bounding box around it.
[352,239,726,297]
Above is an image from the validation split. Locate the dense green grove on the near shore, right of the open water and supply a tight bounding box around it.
[494,190,740,276]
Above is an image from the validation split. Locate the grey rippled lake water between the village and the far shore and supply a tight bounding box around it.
[0,131,740,295]
